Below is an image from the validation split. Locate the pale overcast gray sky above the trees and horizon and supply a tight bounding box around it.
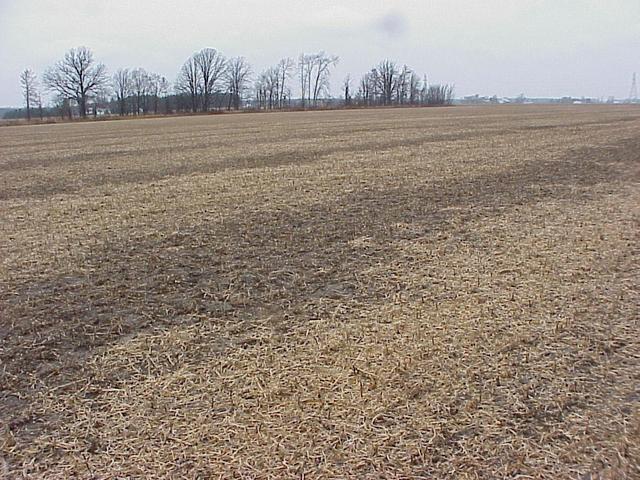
[0,0,640,106]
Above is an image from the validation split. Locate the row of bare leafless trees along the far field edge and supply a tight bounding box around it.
[16,47,453,120]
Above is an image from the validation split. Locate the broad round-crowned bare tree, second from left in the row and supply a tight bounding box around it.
[44,47,107,118]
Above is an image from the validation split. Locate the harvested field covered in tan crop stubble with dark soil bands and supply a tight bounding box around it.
[0,106,640,480]
